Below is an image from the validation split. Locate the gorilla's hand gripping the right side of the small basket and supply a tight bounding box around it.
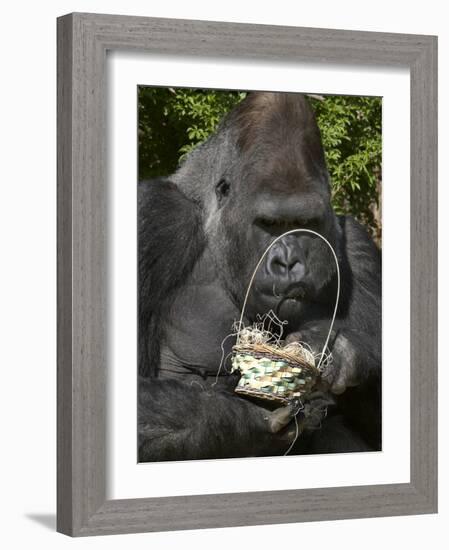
[286,321,360,395]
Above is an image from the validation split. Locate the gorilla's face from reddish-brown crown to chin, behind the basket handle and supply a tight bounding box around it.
[209,93,338,321]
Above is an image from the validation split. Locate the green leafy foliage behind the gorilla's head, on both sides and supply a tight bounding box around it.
[138,86,382,244]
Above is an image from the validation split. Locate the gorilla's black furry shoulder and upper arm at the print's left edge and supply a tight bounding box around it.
[138,179,205,376]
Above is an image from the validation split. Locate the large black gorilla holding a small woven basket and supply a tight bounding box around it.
[138,92,381,462]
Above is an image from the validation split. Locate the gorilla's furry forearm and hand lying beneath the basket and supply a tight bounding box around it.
[138,377,297,462]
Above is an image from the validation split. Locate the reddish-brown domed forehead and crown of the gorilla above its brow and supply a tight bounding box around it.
[223,92,328,198]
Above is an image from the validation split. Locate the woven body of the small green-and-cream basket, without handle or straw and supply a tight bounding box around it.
[231,344,319,405]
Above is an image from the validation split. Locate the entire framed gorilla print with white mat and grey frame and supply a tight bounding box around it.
[58,14,437,536]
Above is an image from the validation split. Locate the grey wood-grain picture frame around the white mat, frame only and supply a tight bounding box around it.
[57,13,437,536]
